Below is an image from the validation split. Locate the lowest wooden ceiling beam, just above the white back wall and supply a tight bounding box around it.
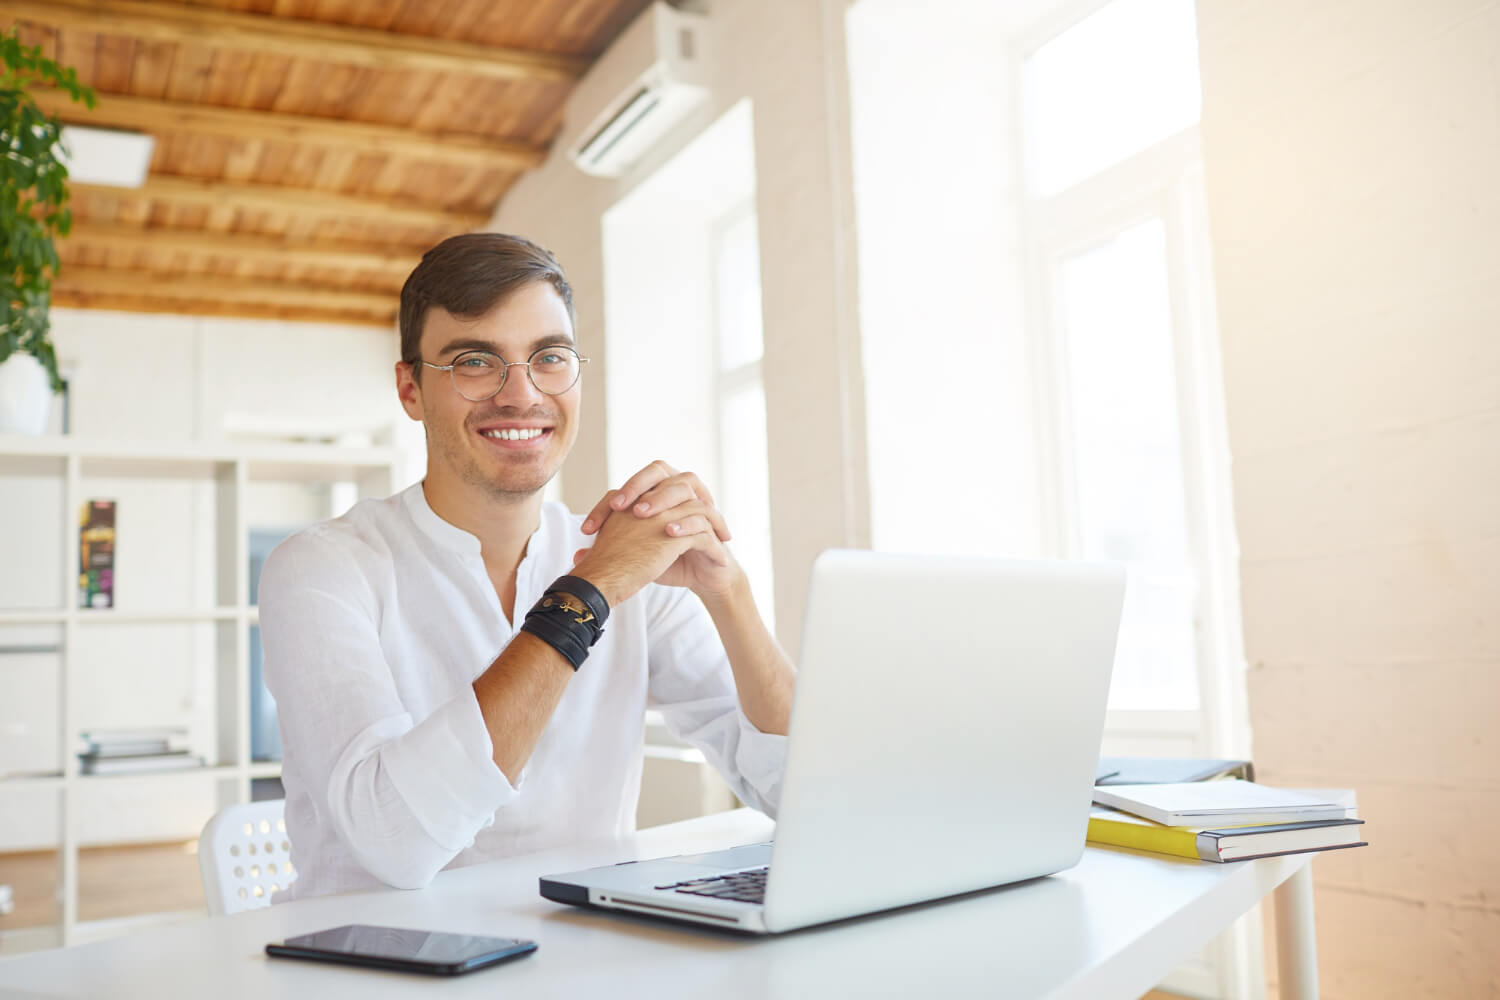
[53,267,399,319]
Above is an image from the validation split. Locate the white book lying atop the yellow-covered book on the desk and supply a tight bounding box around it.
[1094,778,1349,828]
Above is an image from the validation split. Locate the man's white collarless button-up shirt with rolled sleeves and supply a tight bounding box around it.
[260,483,786,898]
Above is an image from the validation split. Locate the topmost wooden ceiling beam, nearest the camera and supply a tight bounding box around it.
[0,0,587,82]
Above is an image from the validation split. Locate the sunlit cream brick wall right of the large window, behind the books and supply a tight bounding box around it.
[1197,0,1500,997]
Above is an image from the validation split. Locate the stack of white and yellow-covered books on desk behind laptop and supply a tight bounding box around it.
[1089,778,1367,862]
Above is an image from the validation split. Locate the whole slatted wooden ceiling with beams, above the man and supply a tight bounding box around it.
[0,0,648,325]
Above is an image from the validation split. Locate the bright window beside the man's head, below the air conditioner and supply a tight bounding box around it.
[603,100,773,625]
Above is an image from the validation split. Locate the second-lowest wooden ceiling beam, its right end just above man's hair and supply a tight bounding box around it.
[63,219,422,279]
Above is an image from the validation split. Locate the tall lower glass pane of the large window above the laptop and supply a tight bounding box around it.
[1058,217,1197,708]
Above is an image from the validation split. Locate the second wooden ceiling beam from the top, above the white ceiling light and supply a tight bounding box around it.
[32,88,546,171]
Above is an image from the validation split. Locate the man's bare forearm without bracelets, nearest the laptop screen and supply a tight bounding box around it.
[701,573,797,736]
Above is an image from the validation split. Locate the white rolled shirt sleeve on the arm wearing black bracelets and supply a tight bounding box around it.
[260,532,518,889]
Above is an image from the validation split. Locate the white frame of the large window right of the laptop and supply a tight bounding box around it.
[1010,9,1266,997]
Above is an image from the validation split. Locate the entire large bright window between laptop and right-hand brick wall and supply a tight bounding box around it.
[1016,0,1263,996]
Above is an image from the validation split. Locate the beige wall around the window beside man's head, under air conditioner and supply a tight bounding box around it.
[491,0,869,649]
